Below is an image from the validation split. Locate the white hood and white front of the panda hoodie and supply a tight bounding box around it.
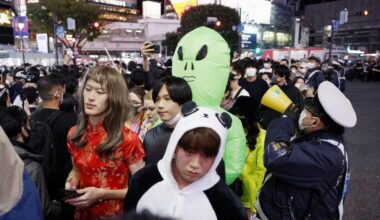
[137,107,228,220]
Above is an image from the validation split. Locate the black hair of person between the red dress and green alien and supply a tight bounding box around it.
[152,76,193,105]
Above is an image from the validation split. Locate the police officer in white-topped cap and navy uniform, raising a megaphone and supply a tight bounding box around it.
[255,81,357,219]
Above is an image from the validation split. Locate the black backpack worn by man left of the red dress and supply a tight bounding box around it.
[27,111,62,186]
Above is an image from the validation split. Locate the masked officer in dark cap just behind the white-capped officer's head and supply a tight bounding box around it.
[305,56,325,92]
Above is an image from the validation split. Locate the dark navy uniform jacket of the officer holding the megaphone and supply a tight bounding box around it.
[256,118,345,219]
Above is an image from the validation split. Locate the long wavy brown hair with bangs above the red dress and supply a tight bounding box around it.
[69,66,132,157]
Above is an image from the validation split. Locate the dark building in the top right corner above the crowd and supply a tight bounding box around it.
[301,0,380,53]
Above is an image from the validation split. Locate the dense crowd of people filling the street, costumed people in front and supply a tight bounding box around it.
[0,27,360,220]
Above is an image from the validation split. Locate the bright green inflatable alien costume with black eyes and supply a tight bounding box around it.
[173,27,246,184]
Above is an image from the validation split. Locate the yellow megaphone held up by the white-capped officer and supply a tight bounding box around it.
[261,85,294,114]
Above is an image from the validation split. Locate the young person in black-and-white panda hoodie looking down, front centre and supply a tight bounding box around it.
[124,102,247,220]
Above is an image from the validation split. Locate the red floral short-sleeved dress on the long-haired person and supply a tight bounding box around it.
[67,123,145,220]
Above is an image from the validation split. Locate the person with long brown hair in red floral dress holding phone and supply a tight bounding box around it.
[65,66,145,220]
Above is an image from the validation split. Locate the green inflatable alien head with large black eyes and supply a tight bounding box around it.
[173,27,230,106]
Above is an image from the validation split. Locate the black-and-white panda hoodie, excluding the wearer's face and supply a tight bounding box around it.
[125,107,245,220]
